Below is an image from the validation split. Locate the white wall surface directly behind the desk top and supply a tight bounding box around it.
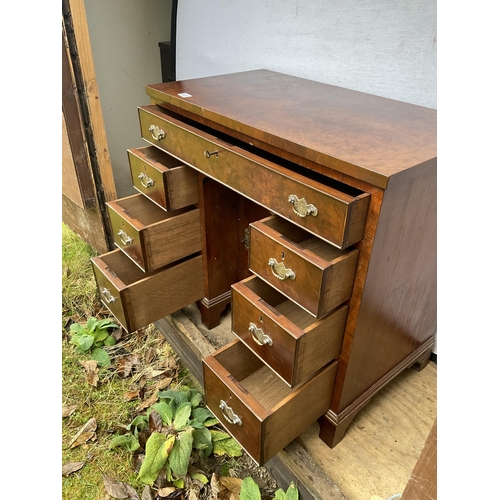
[176,0,436,109]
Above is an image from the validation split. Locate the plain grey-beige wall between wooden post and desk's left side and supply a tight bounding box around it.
[85,0,172,198]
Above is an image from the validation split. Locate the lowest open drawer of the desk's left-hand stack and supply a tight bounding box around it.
[91,249,204,332]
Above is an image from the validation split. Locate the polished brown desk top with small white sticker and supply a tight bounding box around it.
[146,70,437,188]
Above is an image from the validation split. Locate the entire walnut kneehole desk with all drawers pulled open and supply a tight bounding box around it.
[93,70,437,463]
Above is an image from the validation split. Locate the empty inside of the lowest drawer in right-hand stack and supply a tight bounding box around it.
[215,342,293,412]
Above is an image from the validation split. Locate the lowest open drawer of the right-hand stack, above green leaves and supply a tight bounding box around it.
[203,340,337,465]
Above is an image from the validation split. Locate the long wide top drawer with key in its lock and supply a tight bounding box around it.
[139,106,370,252]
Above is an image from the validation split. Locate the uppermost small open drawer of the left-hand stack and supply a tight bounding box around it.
[127,146,198,210]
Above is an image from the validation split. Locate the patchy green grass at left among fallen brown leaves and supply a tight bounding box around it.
[61,225,180,500]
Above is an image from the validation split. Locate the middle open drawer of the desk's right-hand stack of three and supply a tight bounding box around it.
[231,276,348,387]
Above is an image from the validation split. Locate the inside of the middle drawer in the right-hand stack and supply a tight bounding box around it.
[245,277,317,330]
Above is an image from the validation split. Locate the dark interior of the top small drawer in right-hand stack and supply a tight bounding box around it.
[261,216,345,262]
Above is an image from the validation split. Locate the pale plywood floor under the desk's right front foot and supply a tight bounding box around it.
[296,362,437,500]
